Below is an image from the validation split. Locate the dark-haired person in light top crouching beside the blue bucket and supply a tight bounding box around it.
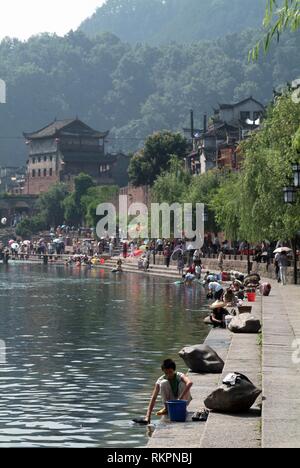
[145,359,193,424]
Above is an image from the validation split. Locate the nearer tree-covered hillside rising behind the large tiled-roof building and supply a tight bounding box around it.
[0,27,300,165]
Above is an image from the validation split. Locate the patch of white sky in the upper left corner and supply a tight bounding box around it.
[0,0,105,40]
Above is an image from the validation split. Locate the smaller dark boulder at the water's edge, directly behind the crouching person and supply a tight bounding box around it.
[179,345,224,374]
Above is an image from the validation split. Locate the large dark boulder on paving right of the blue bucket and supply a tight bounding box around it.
[204,372,261,413]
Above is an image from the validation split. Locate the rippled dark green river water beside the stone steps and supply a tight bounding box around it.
[0,264,207,447]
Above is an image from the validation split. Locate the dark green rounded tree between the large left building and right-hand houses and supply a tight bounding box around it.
[128,131,187,186]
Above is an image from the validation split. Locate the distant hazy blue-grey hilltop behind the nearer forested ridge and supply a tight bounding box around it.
[80,0,266,45]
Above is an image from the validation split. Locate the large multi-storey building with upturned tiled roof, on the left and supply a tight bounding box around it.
[24,118,127,195]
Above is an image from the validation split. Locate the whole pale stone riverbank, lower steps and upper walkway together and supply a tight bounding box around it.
[147,282,300,448]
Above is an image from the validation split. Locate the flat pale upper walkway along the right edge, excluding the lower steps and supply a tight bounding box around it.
[262,282,300,448]
